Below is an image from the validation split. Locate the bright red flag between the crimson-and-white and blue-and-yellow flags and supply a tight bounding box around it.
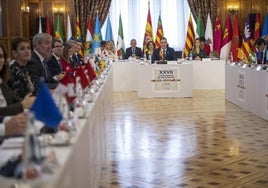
[231,14,241,62]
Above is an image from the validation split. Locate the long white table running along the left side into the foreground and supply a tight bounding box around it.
[0,66,113,188]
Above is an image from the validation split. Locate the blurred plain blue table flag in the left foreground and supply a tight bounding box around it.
[30,81,62,128]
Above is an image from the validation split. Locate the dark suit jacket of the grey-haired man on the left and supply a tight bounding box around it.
[26,51,58,92]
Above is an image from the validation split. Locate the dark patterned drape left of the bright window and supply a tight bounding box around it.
[74,0,111,40]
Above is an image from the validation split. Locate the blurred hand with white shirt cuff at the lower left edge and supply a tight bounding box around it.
[5,113,27,136]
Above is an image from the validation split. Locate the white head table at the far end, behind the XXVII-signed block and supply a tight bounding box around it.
[113,59,225,92]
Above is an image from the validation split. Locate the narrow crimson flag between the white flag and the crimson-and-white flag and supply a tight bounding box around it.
[213,16,222,55]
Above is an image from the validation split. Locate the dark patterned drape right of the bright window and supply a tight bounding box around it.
[188,0,217,27]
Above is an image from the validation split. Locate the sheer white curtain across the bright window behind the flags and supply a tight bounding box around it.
[107,0,190,51]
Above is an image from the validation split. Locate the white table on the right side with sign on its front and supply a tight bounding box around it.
[225,64,268,120]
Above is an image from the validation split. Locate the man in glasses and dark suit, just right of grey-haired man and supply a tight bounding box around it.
[47,38,65,81]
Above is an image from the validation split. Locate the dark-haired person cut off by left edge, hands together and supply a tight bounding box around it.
[0,45,35,117]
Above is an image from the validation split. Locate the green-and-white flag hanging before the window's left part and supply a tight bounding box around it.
[116,14,125,59]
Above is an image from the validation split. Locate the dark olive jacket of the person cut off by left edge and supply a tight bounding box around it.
[0,82,23,117]
